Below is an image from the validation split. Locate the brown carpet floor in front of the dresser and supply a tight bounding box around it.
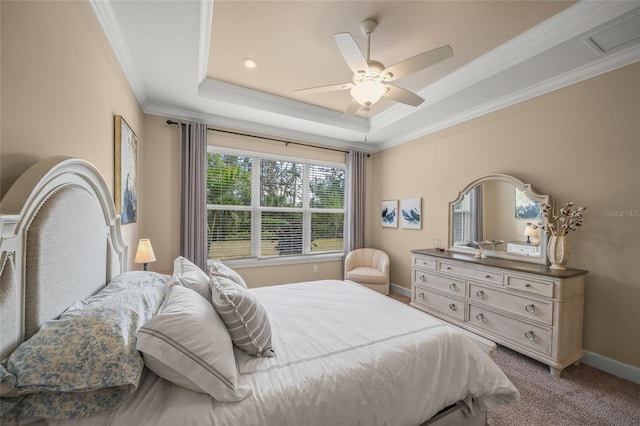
[489,346,640,426]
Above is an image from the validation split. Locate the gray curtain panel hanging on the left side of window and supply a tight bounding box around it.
[178,123,207,271]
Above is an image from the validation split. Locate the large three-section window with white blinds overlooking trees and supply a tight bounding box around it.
[207,147,345,259]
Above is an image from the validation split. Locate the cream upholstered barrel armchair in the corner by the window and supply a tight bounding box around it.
[344,248,390,294]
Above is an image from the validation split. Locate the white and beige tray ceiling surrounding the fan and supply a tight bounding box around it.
[91,0,640,151]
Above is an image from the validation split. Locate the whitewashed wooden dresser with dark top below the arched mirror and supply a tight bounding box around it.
[411,249,587,375]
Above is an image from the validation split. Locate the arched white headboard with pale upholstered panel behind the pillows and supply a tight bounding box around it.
[0,157,127,359]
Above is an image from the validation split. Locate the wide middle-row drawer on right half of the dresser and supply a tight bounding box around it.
[469,283,553,325]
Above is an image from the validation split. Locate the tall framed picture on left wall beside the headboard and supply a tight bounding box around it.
[113,115,138,225]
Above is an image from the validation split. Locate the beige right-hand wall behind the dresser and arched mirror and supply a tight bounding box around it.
[367,63,640,367]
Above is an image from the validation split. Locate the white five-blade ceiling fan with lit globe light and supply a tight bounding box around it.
[293,19,453,115]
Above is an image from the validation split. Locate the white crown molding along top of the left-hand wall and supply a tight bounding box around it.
[89,0,147,105]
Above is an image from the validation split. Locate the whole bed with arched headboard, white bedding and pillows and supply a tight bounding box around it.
[0,157,519,426]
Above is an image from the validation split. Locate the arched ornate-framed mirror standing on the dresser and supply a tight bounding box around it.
[449,174,549,264]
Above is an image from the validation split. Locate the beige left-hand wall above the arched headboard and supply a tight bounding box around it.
[0,1,144,267]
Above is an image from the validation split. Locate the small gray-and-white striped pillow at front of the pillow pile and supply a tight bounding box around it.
[209,276,273,357]
